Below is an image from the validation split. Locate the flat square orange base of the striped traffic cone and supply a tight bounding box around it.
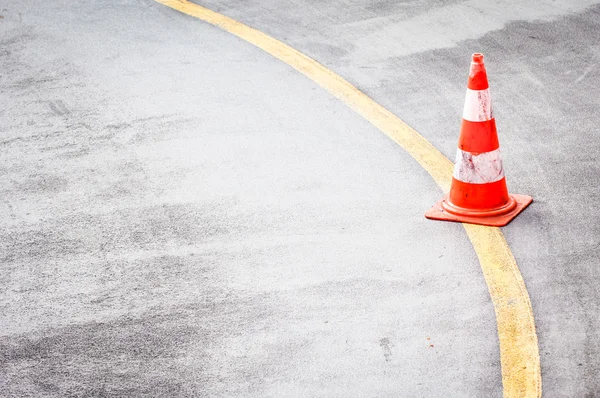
[425,194,533,227]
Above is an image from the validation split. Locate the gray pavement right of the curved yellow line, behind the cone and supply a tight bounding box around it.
[193,0,600,397]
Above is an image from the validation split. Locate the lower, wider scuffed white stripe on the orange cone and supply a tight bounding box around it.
[453,149,504,184]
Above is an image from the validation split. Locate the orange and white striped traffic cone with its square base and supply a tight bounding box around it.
[425,54,533,227]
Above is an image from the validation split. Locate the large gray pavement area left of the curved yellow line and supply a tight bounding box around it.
[0,1,501,397]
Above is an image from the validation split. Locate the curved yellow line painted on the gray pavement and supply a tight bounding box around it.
[156,0,542,398]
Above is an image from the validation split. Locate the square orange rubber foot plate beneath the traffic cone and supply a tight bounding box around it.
[425,194,533,227]
